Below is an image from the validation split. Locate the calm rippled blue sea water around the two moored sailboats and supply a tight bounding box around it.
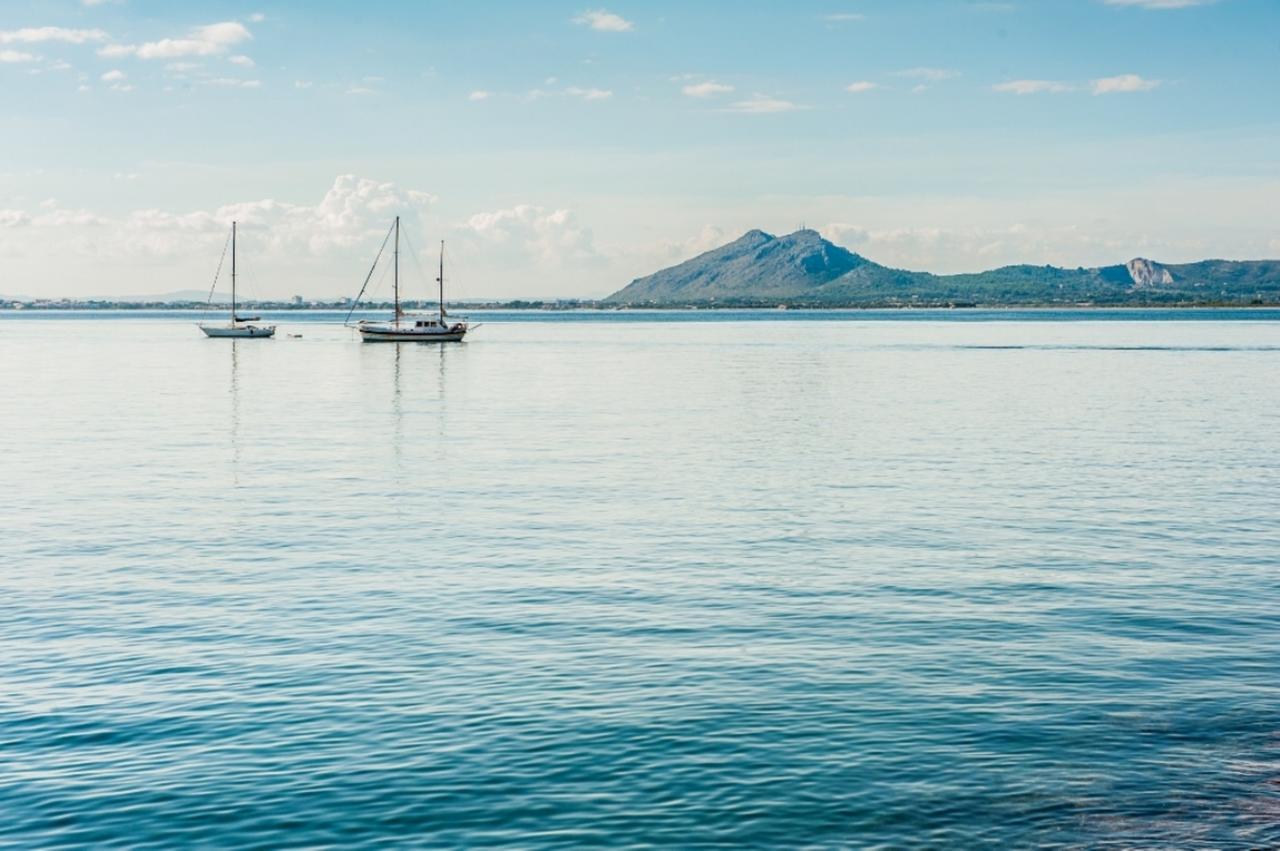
[0,312,1280,848]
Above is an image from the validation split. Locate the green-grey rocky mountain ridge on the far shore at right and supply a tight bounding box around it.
[605,230,1280,306]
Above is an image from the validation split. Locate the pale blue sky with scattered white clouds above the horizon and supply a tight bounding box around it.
[0,0,1280,298]
